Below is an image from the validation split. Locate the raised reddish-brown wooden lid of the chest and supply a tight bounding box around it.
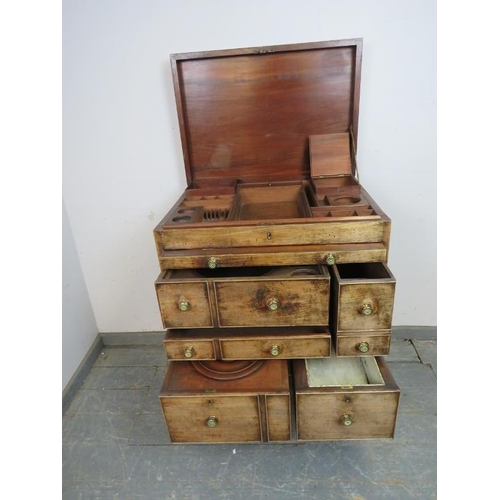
[171,39,362,186]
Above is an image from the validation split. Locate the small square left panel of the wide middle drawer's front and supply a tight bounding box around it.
[156,282,213,328]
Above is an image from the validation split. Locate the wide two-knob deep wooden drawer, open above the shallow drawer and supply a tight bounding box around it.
[156,266,330,328]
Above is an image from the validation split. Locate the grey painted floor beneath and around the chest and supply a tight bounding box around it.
[62,335,437,500]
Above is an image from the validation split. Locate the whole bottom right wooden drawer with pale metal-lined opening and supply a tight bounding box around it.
[293,356,400,441]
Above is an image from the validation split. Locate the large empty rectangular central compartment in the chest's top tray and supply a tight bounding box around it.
[230,184,312,220]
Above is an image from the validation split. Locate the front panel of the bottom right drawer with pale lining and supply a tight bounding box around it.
[297,391,399,441]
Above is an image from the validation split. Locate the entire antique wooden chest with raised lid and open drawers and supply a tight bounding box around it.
[154,39,399,443]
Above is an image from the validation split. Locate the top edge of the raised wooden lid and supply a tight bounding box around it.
[170,38,363,64]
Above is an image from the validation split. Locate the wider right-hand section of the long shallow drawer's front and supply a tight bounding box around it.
[220,333,331,360]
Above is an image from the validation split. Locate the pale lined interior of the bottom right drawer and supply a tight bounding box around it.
[305,355,384,387]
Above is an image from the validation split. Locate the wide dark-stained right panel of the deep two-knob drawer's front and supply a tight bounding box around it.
[215,279,330,327]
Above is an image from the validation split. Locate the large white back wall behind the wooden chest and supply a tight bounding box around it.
[63,0,436,332]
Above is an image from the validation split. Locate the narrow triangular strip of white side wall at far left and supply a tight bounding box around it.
[62,202,98,390]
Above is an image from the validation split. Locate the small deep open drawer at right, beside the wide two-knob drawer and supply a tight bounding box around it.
[332,262,396,334]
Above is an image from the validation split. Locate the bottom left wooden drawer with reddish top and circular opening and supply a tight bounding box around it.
[159,360,291,443]
